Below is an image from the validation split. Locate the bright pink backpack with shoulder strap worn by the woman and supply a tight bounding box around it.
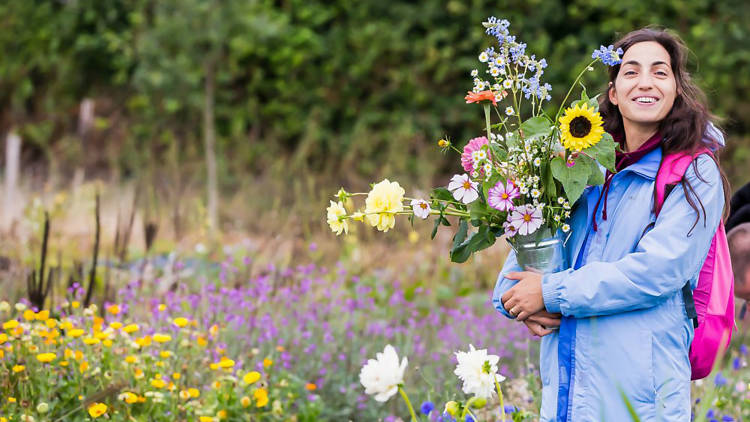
[655,149,734,380]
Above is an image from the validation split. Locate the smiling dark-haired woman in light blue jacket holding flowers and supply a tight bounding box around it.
[493,28,728,421]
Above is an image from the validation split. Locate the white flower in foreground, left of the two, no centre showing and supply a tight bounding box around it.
[359,344,408,402]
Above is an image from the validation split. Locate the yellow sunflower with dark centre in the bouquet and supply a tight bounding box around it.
[560,104,604,151]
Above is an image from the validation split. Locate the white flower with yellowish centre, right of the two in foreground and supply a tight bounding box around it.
[454,344,505,399]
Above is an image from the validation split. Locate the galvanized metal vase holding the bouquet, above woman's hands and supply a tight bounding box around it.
[509,233,568,274]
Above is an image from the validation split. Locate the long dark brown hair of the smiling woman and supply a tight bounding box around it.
[599,27,731,232]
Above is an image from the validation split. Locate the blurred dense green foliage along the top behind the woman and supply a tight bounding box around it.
[0,0,750,188]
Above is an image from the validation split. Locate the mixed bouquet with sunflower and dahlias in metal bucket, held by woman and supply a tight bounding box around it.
[327,17,622,272]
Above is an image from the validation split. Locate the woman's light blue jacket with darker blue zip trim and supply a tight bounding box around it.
[493,148,724,422]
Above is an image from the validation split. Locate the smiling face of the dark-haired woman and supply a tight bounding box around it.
[609,41,677,132]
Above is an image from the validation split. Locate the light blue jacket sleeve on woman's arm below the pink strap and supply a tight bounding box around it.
[542,155,724,317]
